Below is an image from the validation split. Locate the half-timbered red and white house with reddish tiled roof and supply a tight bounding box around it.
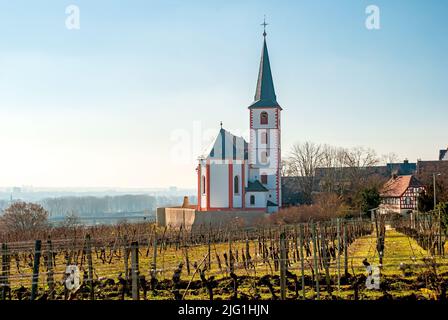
[379,175,425,214]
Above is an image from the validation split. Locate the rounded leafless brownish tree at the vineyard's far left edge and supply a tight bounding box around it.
[0,202,48,233]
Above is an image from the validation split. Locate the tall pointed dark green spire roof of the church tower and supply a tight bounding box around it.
[249,33,280,109]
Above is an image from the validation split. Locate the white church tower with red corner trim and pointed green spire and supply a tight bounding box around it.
[249,22,282,212]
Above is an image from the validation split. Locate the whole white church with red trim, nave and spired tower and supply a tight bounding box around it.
[196,23,282,213]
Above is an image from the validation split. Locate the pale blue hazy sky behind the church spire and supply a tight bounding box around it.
[0,0,448,188]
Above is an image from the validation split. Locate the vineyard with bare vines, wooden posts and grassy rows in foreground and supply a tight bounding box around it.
[0,216,448,300]
